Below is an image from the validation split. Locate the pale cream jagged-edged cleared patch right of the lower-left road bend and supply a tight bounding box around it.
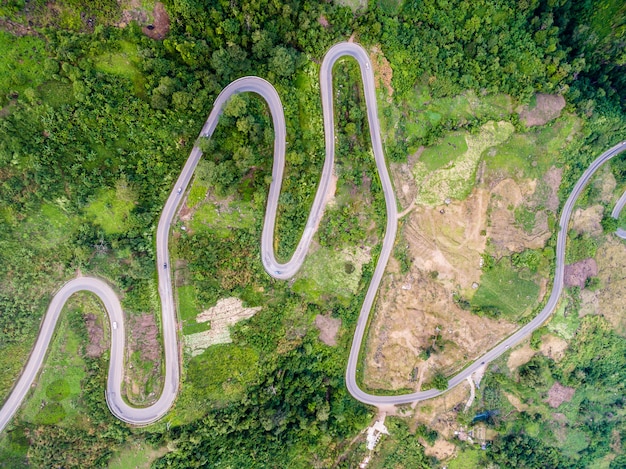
[185,297,262,357]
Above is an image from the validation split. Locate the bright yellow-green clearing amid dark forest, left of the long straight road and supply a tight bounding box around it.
[85,189,135,234]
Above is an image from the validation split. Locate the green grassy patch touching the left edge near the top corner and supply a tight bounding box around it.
[0,30,48,106]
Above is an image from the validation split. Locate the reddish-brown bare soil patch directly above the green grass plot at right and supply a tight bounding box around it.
[487,175,558,257]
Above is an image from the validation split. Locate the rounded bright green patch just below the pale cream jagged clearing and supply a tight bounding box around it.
[187,344,259,402]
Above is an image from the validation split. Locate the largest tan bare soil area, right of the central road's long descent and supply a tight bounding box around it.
[364,189,516,390]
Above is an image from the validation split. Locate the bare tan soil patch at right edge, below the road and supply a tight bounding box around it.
[596,236,626,337]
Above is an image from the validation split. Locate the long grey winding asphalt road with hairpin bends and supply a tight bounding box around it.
[0,43,626,431]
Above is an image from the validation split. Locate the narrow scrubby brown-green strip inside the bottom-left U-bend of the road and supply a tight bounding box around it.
[124,313,163,405]
